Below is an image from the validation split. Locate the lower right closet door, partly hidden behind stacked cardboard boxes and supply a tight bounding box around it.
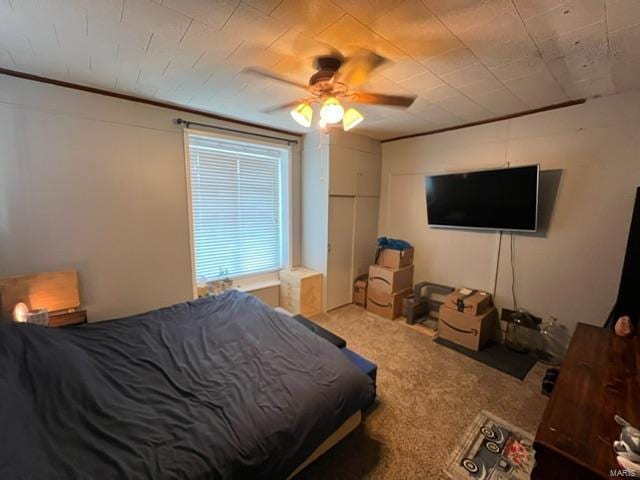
[353,197,380,278]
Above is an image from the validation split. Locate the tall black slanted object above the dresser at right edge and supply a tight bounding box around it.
[607,187,640,326]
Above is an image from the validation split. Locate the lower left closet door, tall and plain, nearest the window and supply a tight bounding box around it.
[326,197,355,310]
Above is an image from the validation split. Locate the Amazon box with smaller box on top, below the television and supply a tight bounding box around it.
[438,288,498,350]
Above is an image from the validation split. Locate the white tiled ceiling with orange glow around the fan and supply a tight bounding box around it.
[0,0,640,139]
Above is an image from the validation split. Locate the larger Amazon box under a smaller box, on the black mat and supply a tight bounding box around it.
[438,308,498,350]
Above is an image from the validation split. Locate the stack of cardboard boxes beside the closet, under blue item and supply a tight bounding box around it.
[366,248,413,320]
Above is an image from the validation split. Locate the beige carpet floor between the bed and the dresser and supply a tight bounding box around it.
[297,305,547,480]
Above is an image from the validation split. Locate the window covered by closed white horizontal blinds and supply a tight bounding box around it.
[186,133,290,281]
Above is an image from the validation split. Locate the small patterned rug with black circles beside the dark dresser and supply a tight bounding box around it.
[444,410,535,480]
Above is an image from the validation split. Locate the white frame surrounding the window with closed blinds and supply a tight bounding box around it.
[182,127,294,298]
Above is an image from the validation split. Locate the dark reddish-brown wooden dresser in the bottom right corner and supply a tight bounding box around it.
[531,324,640,480]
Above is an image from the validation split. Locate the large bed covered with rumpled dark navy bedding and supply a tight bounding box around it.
[0,291,374,479]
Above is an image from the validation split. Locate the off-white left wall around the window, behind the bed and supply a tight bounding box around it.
[0,75,300,320]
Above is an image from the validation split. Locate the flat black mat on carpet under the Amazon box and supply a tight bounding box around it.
[434,337,538,380]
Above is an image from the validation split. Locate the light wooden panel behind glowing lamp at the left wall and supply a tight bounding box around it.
[0,271,80,318]
